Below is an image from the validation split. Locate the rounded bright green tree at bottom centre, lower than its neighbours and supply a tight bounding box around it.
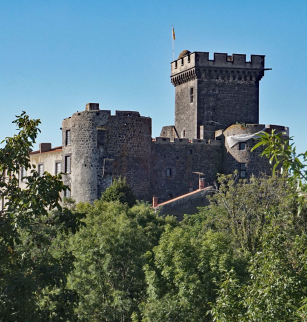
[142,220,248,322]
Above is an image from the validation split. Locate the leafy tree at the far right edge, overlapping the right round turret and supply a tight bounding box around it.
[211,133,307,322]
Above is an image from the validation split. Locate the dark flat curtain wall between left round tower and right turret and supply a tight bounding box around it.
[151,137,223,202]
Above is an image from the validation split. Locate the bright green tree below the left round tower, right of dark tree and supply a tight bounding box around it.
[70,198,177,322]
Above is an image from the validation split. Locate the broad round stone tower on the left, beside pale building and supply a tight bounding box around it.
[62,108,151,202]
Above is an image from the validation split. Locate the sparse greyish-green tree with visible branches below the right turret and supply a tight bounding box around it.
[201,174,300,255]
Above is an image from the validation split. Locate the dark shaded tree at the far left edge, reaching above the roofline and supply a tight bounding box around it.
[0,112,82,322]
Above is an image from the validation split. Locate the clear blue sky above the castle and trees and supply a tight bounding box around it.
[0,0,307,151]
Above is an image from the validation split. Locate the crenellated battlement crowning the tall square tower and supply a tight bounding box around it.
[171,52,265,76]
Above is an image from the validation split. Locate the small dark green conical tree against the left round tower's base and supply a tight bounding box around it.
[101,177,136,207]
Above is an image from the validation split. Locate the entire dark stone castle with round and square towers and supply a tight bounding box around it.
[20,50,287,202]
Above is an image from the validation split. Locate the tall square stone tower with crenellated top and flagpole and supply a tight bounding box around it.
[171,50,265,139]
